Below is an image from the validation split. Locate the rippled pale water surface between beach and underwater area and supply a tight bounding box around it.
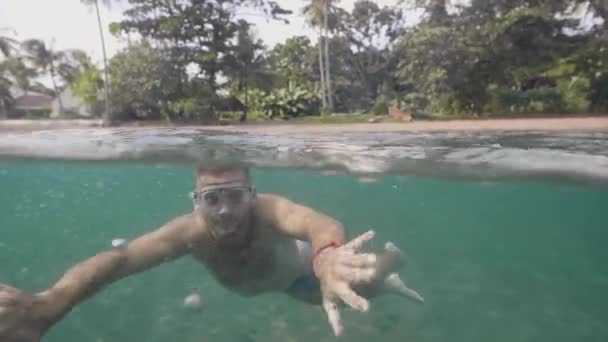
[0,128,608,187]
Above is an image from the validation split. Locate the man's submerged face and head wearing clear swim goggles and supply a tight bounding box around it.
[193,169,254,239]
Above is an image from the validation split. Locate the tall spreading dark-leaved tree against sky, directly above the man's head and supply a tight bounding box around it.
[114,0,289,94]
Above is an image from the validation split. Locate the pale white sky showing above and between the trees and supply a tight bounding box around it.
[0,0,408,65]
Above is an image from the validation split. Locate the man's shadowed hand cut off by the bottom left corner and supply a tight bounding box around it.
[0,283,57,342]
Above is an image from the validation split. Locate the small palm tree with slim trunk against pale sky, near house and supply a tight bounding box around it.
[21,39,65,111]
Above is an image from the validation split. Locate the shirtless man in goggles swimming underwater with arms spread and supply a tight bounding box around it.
[0,167,423,342]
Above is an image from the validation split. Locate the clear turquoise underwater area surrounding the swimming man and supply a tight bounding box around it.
[0,129,608,342]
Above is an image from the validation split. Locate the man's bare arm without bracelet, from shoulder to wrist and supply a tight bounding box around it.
[40,215,204,319]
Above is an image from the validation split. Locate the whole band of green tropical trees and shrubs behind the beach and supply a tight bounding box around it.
[0,0,608,123]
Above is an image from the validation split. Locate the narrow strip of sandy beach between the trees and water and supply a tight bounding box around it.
[0,116,608,134]
